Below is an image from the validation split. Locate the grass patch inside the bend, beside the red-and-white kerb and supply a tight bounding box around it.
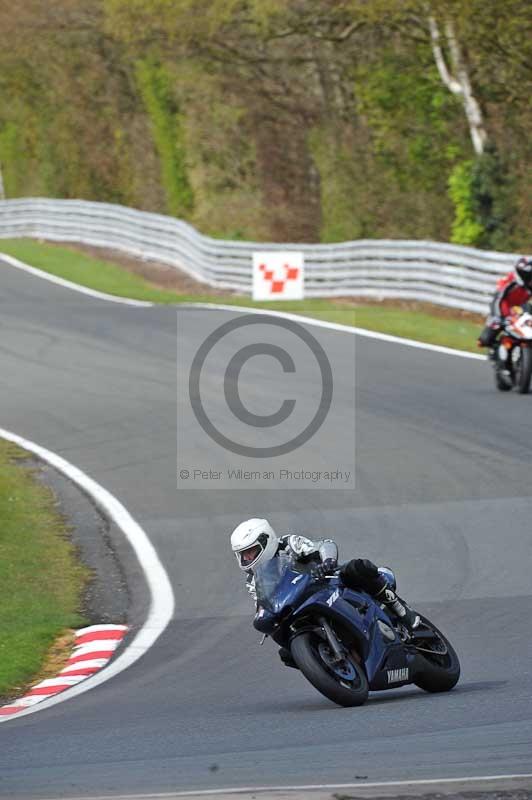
[0,440,89,698]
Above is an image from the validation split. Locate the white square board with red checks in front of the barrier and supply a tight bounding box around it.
[253,252,304,300]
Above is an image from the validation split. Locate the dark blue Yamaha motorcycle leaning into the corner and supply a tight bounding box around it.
[253,556,460,706]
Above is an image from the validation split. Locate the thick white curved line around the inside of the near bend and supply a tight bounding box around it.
[0,428,175,723]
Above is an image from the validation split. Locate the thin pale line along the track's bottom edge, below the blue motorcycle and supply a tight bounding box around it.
[44,772,532,800]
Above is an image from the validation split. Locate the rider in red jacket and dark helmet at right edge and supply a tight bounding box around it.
[478,256,532,347]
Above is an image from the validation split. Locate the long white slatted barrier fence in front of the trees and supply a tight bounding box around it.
[0,199,517,313]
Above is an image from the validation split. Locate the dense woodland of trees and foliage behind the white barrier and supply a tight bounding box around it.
[0,0,532,250]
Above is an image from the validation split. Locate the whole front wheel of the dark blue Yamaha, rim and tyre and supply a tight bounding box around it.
[290,631,369,708]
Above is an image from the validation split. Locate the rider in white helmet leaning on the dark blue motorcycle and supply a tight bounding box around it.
[231,519,420,663]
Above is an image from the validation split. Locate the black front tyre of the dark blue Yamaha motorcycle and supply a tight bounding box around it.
[290,631,369,708]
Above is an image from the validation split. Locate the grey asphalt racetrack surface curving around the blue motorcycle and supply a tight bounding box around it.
[0,264,532,798]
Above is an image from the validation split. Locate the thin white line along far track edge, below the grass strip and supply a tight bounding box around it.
[0,252,486,361]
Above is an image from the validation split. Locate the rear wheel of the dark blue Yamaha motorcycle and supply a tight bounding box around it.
[414,617,460,692]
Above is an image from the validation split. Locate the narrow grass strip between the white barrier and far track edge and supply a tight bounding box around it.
[0,239,479,351]
